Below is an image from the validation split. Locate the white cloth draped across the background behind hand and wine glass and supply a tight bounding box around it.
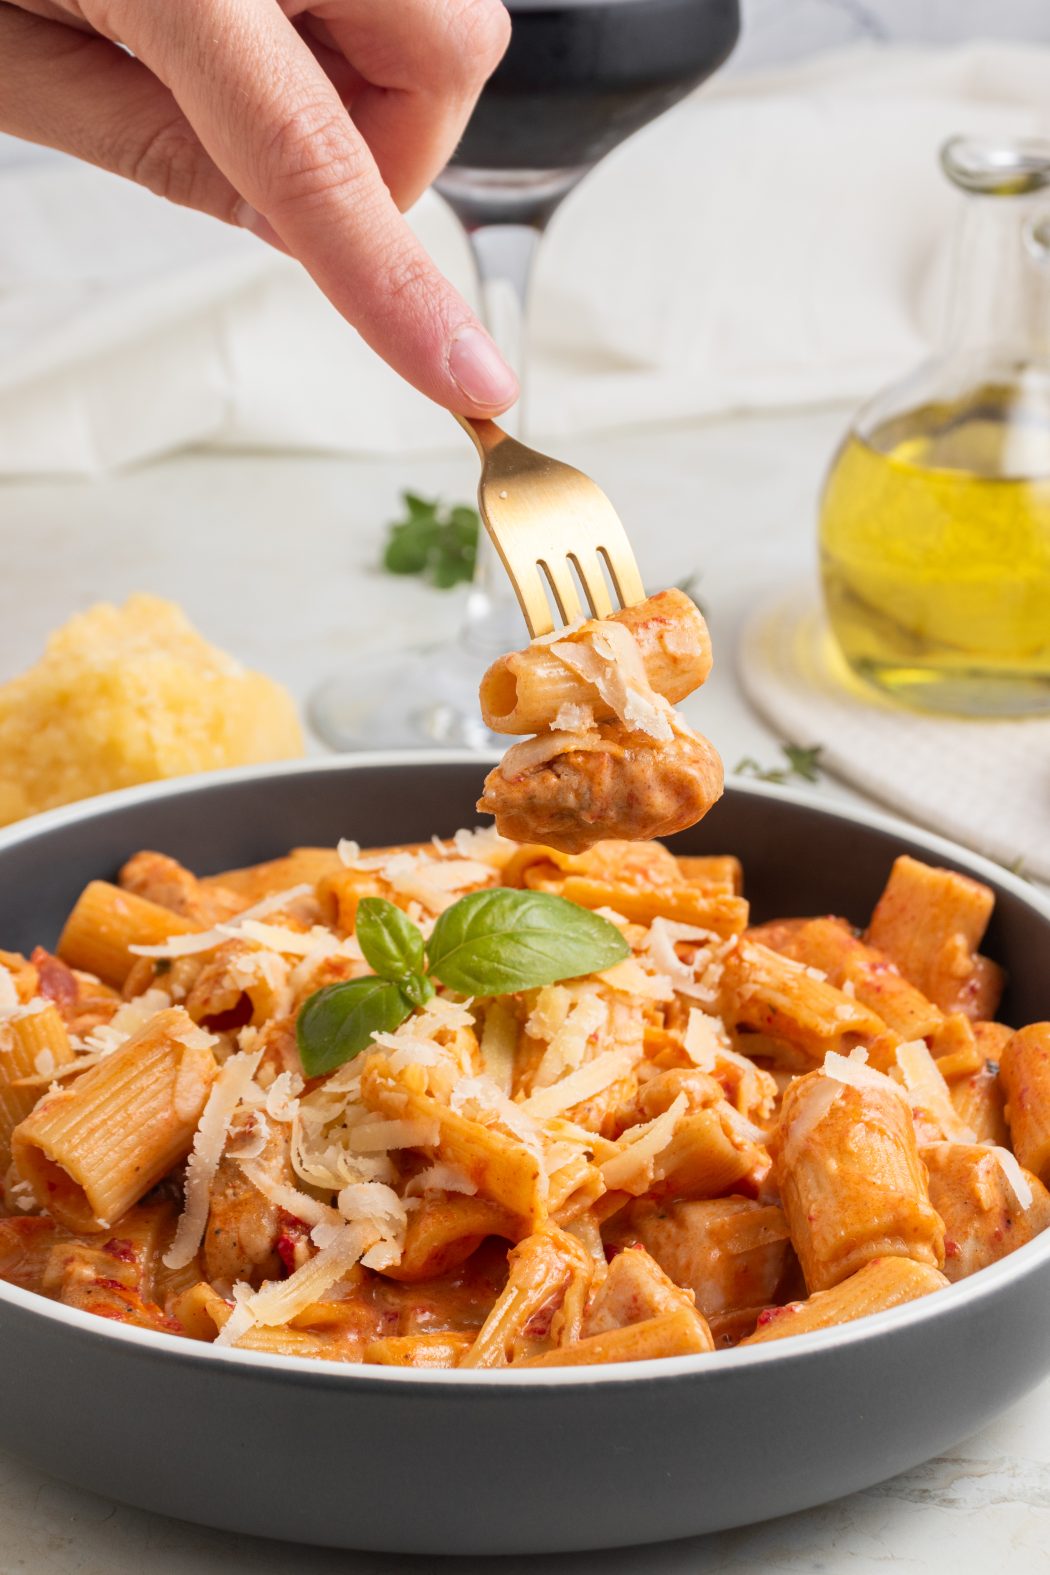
[0,44,1050,474]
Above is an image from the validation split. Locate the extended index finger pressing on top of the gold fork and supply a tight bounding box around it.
[82,0,518,416]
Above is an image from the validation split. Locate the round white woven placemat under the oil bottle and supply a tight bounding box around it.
[738,586,1050,880]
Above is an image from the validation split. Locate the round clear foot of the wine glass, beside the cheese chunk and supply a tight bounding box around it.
[307,644,507,751]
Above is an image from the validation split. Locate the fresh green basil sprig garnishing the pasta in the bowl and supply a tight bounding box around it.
[296,887,630,1077]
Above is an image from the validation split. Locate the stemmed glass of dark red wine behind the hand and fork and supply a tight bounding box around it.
[310,0,740,750]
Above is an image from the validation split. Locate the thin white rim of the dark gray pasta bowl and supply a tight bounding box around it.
[0,750,1050,1395]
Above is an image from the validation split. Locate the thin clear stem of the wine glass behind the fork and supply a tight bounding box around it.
[460,224,542,657]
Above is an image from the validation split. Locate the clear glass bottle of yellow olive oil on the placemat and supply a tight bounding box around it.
[820,139,1050,717]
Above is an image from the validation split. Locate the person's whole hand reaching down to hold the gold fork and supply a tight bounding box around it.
[0,0,518,416]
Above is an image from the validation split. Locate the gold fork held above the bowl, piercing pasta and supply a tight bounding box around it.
[457,416,645,639]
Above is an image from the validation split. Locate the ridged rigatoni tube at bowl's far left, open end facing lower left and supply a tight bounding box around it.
[11,1006,217,1233]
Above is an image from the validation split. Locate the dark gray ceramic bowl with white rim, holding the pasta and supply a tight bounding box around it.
[0,754,1050,1553]
